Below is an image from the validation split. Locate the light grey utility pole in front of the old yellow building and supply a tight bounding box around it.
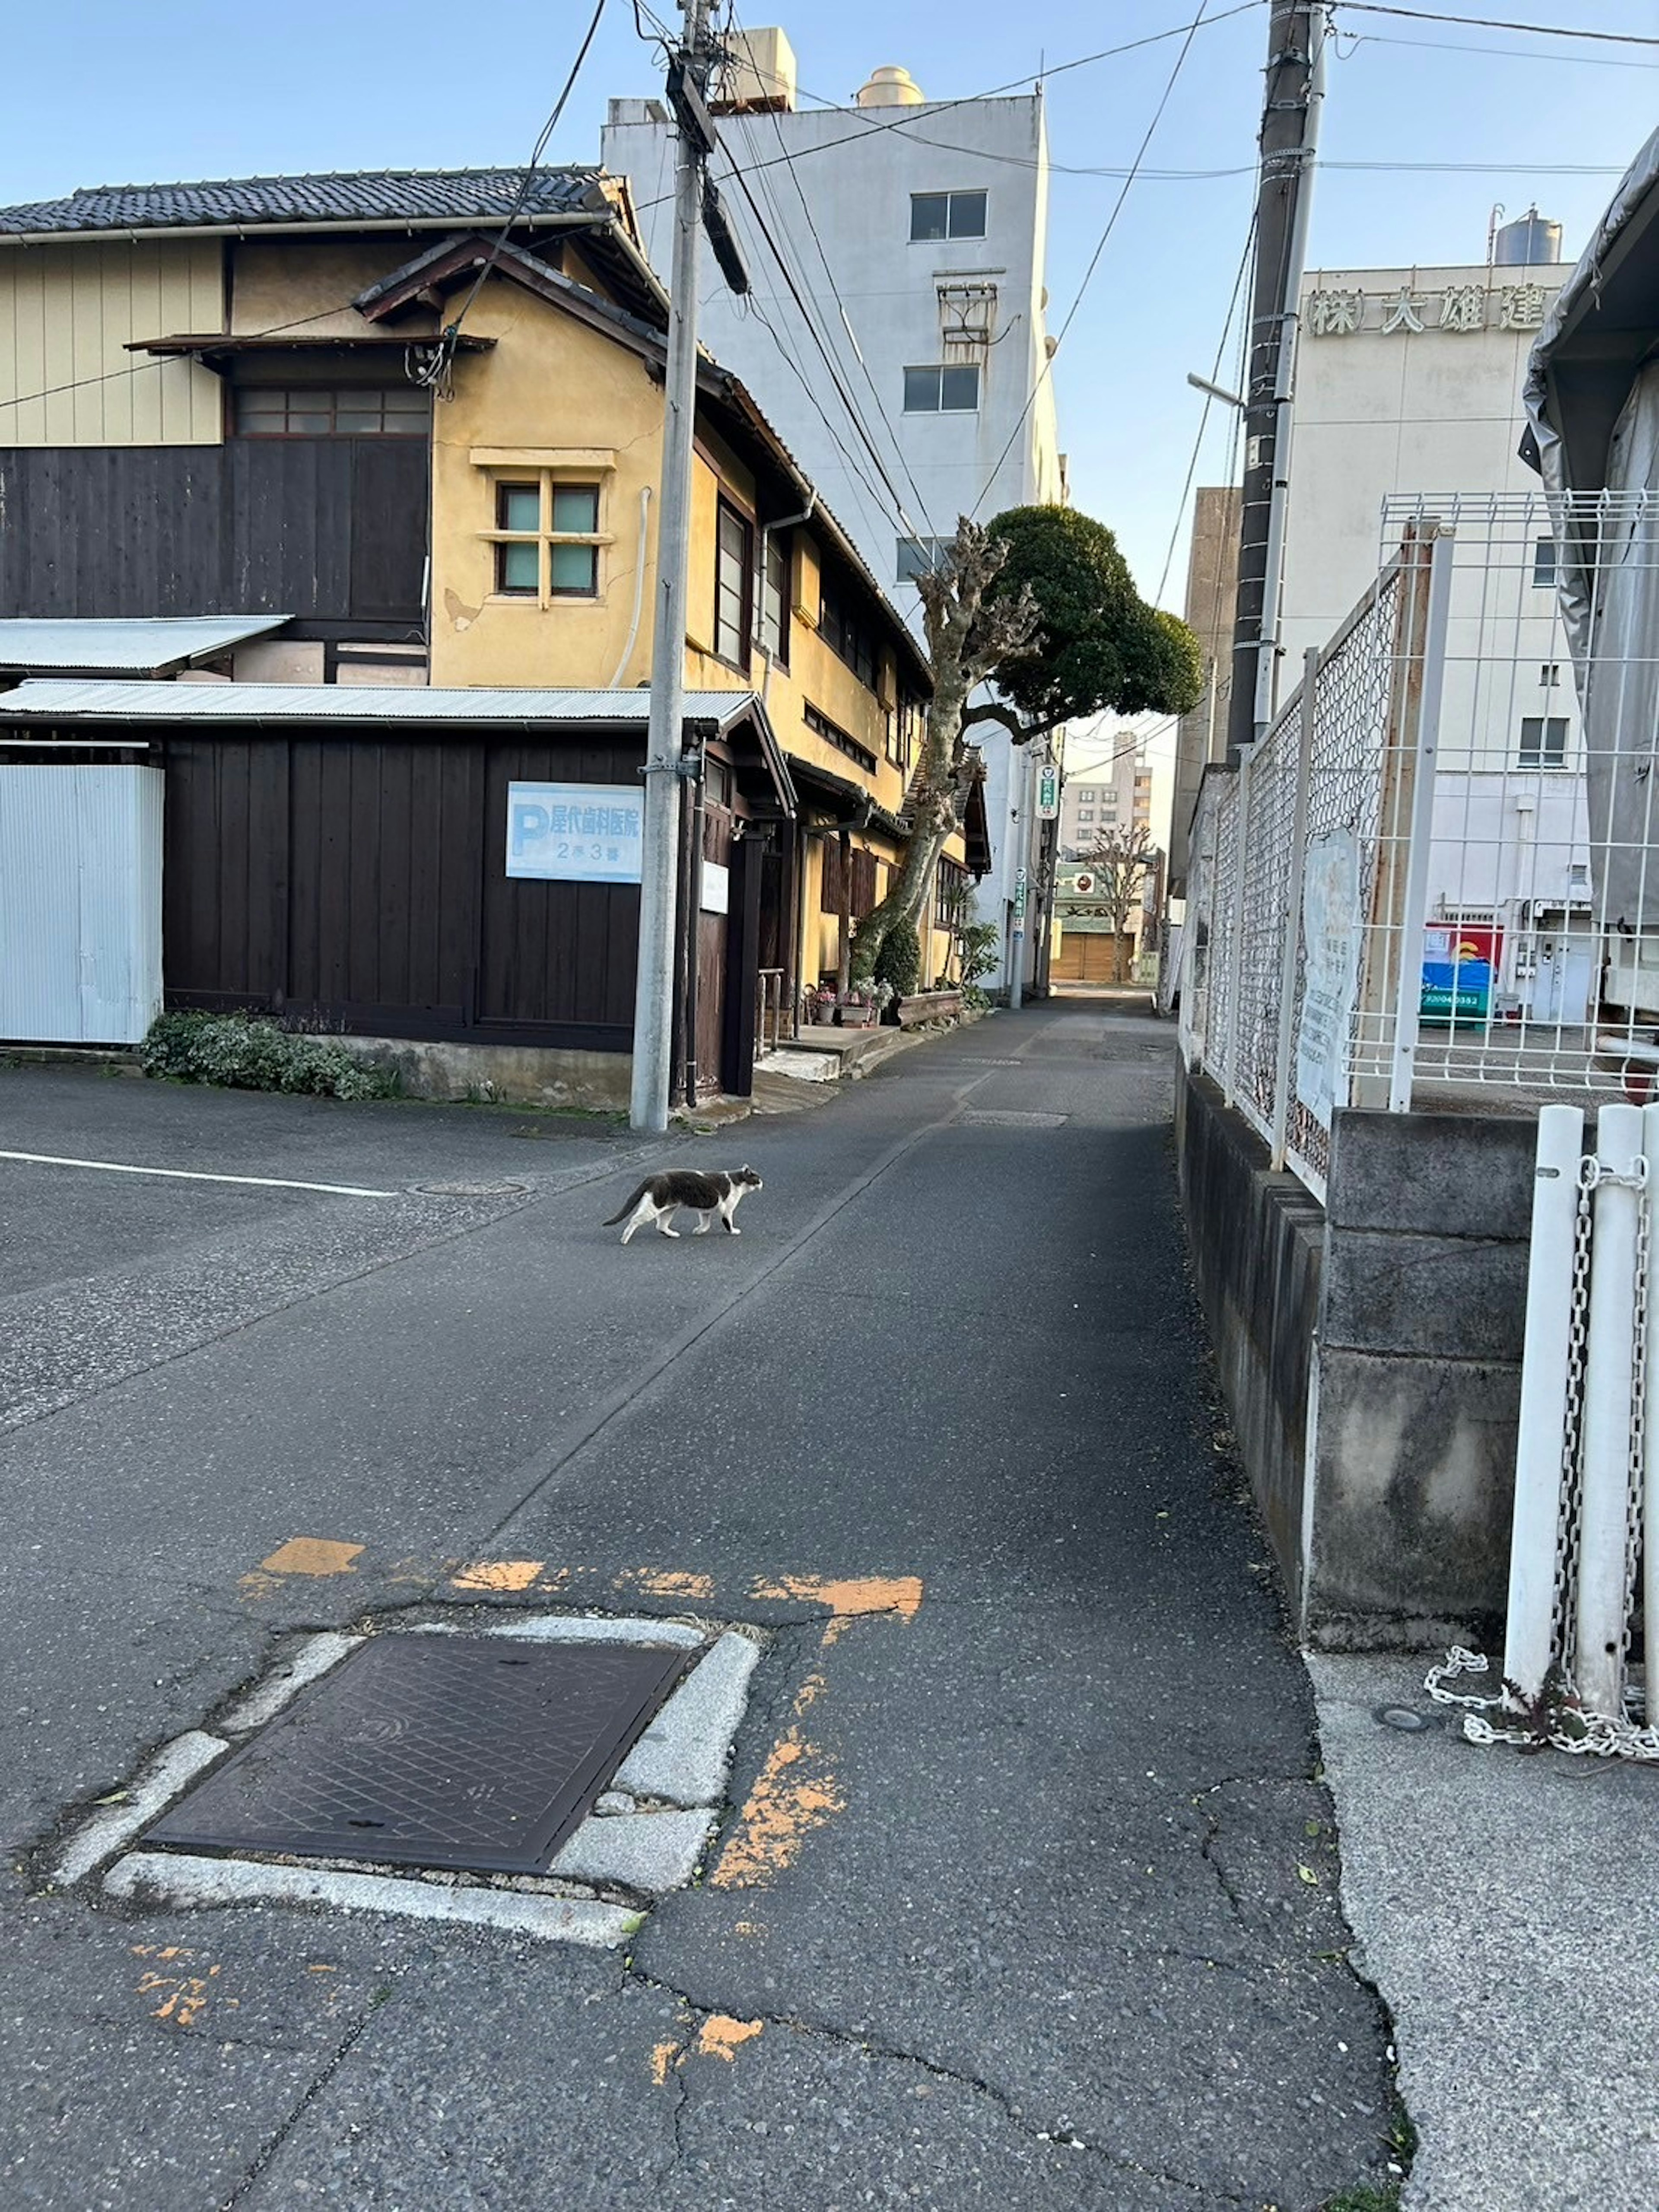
[628,0,715,1135]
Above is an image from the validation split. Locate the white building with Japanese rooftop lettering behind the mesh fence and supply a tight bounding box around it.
[1278,215,1592,1024]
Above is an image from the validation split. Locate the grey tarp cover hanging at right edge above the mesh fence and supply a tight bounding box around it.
[1522,130,1659,931]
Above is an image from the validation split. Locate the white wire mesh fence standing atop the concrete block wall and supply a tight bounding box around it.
[1181,493,1659,1197]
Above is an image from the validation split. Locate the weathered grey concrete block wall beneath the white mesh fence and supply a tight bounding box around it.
[1177,1075,1535,1650]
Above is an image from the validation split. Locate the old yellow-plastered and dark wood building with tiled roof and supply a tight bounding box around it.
[0,170,982,1088]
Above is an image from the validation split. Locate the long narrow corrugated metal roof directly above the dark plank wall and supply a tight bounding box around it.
[0,679,759,726]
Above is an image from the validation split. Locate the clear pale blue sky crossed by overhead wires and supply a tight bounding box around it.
[0,0,1659,604]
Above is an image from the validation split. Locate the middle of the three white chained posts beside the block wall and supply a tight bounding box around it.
[1577,1104,1641,1714]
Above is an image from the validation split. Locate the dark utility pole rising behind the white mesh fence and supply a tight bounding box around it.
[1228,0,1327,763]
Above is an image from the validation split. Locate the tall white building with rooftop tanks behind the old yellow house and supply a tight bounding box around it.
[604,29,1066,987]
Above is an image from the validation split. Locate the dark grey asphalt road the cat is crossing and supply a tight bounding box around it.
[0,1009,1394,2212]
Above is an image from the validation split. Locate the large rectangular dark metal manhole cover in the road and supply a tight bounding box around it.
[144,1635,686,1874]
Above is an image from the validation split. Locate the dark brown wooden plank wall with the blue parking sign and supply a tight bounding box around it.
[162,730,642,1051]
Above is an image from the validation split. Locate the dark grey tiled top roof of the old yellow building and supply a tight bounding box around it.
[0,168,606,237]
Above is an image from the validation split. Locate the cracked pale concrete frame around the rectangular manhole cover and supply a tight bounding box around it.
[51,1610,761,1949]
